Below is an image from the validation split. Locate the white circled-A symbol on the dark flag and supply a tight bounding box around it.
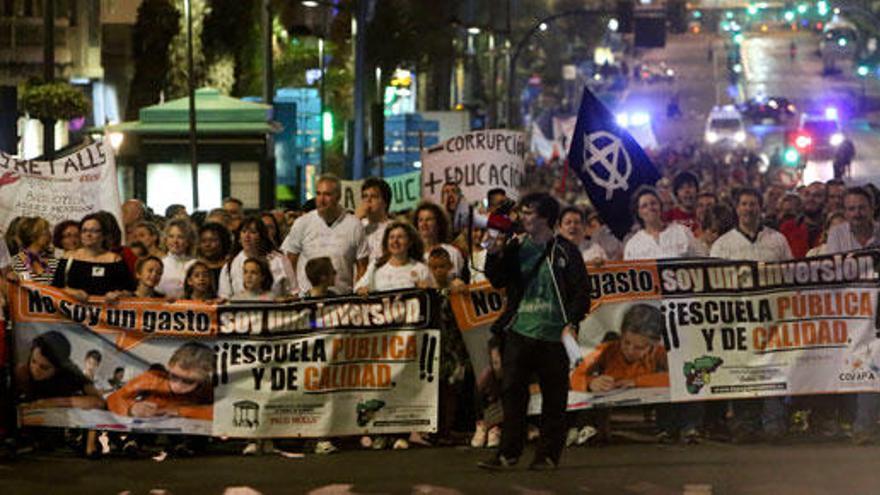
[582,131,632,200]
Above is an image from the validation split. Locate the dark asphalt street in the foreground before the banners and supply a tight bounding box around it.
[0,441,880,495]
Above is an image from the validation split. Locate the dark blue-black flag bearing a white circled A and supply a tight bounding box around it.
[568,88,660,239]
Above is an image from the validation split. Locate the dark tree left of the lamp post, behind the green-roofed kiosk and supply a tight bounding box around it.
[125,0,181,120]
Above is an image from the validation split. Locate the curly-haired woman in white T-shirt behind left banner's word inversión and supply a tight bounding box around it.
[355,222,435,294]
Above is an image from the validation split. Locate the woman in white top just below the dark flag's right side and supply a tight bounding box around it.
[623,186,707,260]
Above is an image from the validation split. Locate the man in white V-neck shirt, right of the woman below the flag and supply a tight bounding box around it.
[711,188,792,442]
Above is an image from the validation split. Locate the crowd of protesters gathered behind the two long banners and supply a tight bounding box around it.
[0,146,880,464]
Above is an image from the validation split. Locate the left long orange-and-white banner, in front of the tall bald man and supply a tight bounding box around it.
[9,283,441,438]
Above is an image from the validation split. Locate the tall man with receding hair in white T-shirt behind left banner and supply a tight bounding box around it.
[281,174,369,294]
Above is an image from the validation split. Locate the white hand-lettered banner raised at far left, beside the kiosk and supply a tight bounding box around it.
[0,143,122,234]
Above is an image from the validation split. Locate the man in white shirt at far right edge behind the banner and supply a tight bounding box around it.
[824,187,880,445]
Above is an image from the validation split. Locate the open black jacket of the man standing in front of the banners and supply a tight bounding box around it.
[486,235,590,335]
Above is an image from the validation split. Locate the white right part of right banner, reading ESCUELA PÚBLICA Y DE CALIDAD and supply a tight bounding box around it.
[660,251,880,401]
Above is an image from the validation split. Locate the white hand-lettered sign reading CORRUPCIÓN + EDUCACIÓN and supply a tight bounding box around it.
[422,129,528,204]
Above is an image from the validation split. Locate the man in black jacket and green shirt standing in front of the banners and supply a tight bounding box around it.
[478,193,590,470]
